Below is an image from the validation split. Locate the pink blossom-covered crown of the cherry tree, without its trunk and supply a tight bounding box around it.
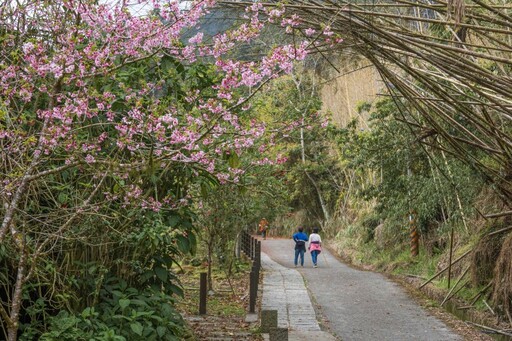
[0,0,340,211]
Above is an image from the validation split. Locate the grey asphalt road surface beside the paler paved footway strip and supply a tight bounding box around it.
[262,239,462,341]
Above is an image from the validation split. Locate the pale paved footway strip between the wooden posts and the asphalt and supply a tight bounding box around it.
[261,253,336,341]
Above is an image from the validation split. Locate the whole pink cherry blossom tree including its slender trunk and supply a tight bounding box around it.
[0,0,314,340]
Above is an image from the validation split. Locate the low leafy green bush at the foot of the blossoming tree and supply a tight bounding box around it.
[35,278,185,341]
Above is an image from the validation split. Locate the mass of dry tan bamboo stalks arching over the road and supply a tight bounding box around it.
[220,0,512,218]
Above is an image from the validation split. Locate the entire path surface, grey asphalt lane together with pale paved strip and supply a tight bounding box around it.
[262,239,462,341]
